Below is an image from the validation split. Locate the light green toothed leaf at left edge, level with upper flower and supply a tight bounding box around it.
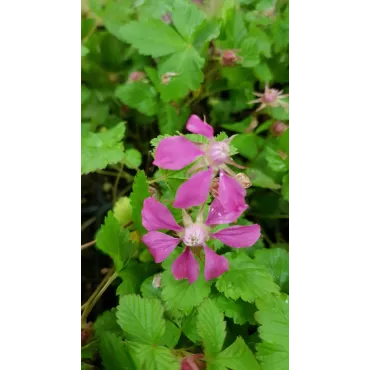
[80,122,125,175]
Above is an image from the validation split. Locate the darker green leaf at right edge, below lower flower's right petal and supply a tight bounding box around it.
[254,248,290,289]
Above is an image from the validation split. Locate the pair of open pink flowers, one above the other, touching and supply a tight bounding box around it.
[142,115,260,283]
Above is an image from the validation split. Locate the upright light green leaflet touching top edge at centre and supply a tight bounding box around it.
[172,0,205,42]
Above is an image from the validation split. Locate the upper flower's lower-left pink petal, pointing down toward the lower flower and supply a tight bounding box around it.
[173,167,213,208]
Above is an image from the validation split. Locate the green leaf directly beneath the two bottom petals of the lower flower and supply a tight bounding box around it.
[162,271,211,311]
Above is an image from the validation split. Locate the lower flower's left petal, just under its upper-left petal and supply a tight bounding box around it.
[142,231,180,263]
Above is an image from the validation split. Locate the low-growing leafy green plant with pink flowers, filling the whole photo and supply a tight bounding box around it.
[80,0,290,370]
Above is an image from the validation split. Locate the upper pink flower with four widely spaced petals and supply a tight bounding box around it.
[153,114,246,212]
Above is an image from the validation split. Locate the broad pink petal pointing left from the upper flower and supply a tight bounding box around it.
[153,136,204,170]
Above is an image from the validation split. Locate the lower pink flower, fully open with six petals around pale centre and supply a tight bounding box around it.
[141,197,260,284]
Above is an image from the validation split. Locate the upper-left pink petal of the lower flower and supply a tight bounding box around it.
[141,197,182,231]
